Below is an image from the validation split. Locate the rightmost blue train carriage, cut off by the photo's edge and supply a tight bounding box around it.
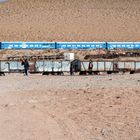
[107,42,137,50]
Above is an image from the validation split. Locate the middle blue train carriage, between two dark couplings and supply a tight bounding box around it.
[56,42,107,50]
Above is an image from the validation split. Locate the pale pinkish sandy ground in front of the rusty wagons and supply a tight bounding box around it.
[0,74,140,140]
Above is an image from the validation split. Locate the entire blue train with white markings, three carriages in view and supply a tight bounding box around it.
[0,42,140,50]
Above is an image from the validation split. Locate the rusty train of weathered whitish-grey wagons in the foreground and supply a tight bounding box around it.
[0,60,140,75]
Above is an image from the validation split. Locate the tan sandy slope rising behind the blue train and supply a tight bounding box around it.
[0,0,140,41]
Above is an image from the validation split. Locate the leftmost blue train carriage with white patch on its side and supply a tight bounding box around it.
[1,42,55,49]
